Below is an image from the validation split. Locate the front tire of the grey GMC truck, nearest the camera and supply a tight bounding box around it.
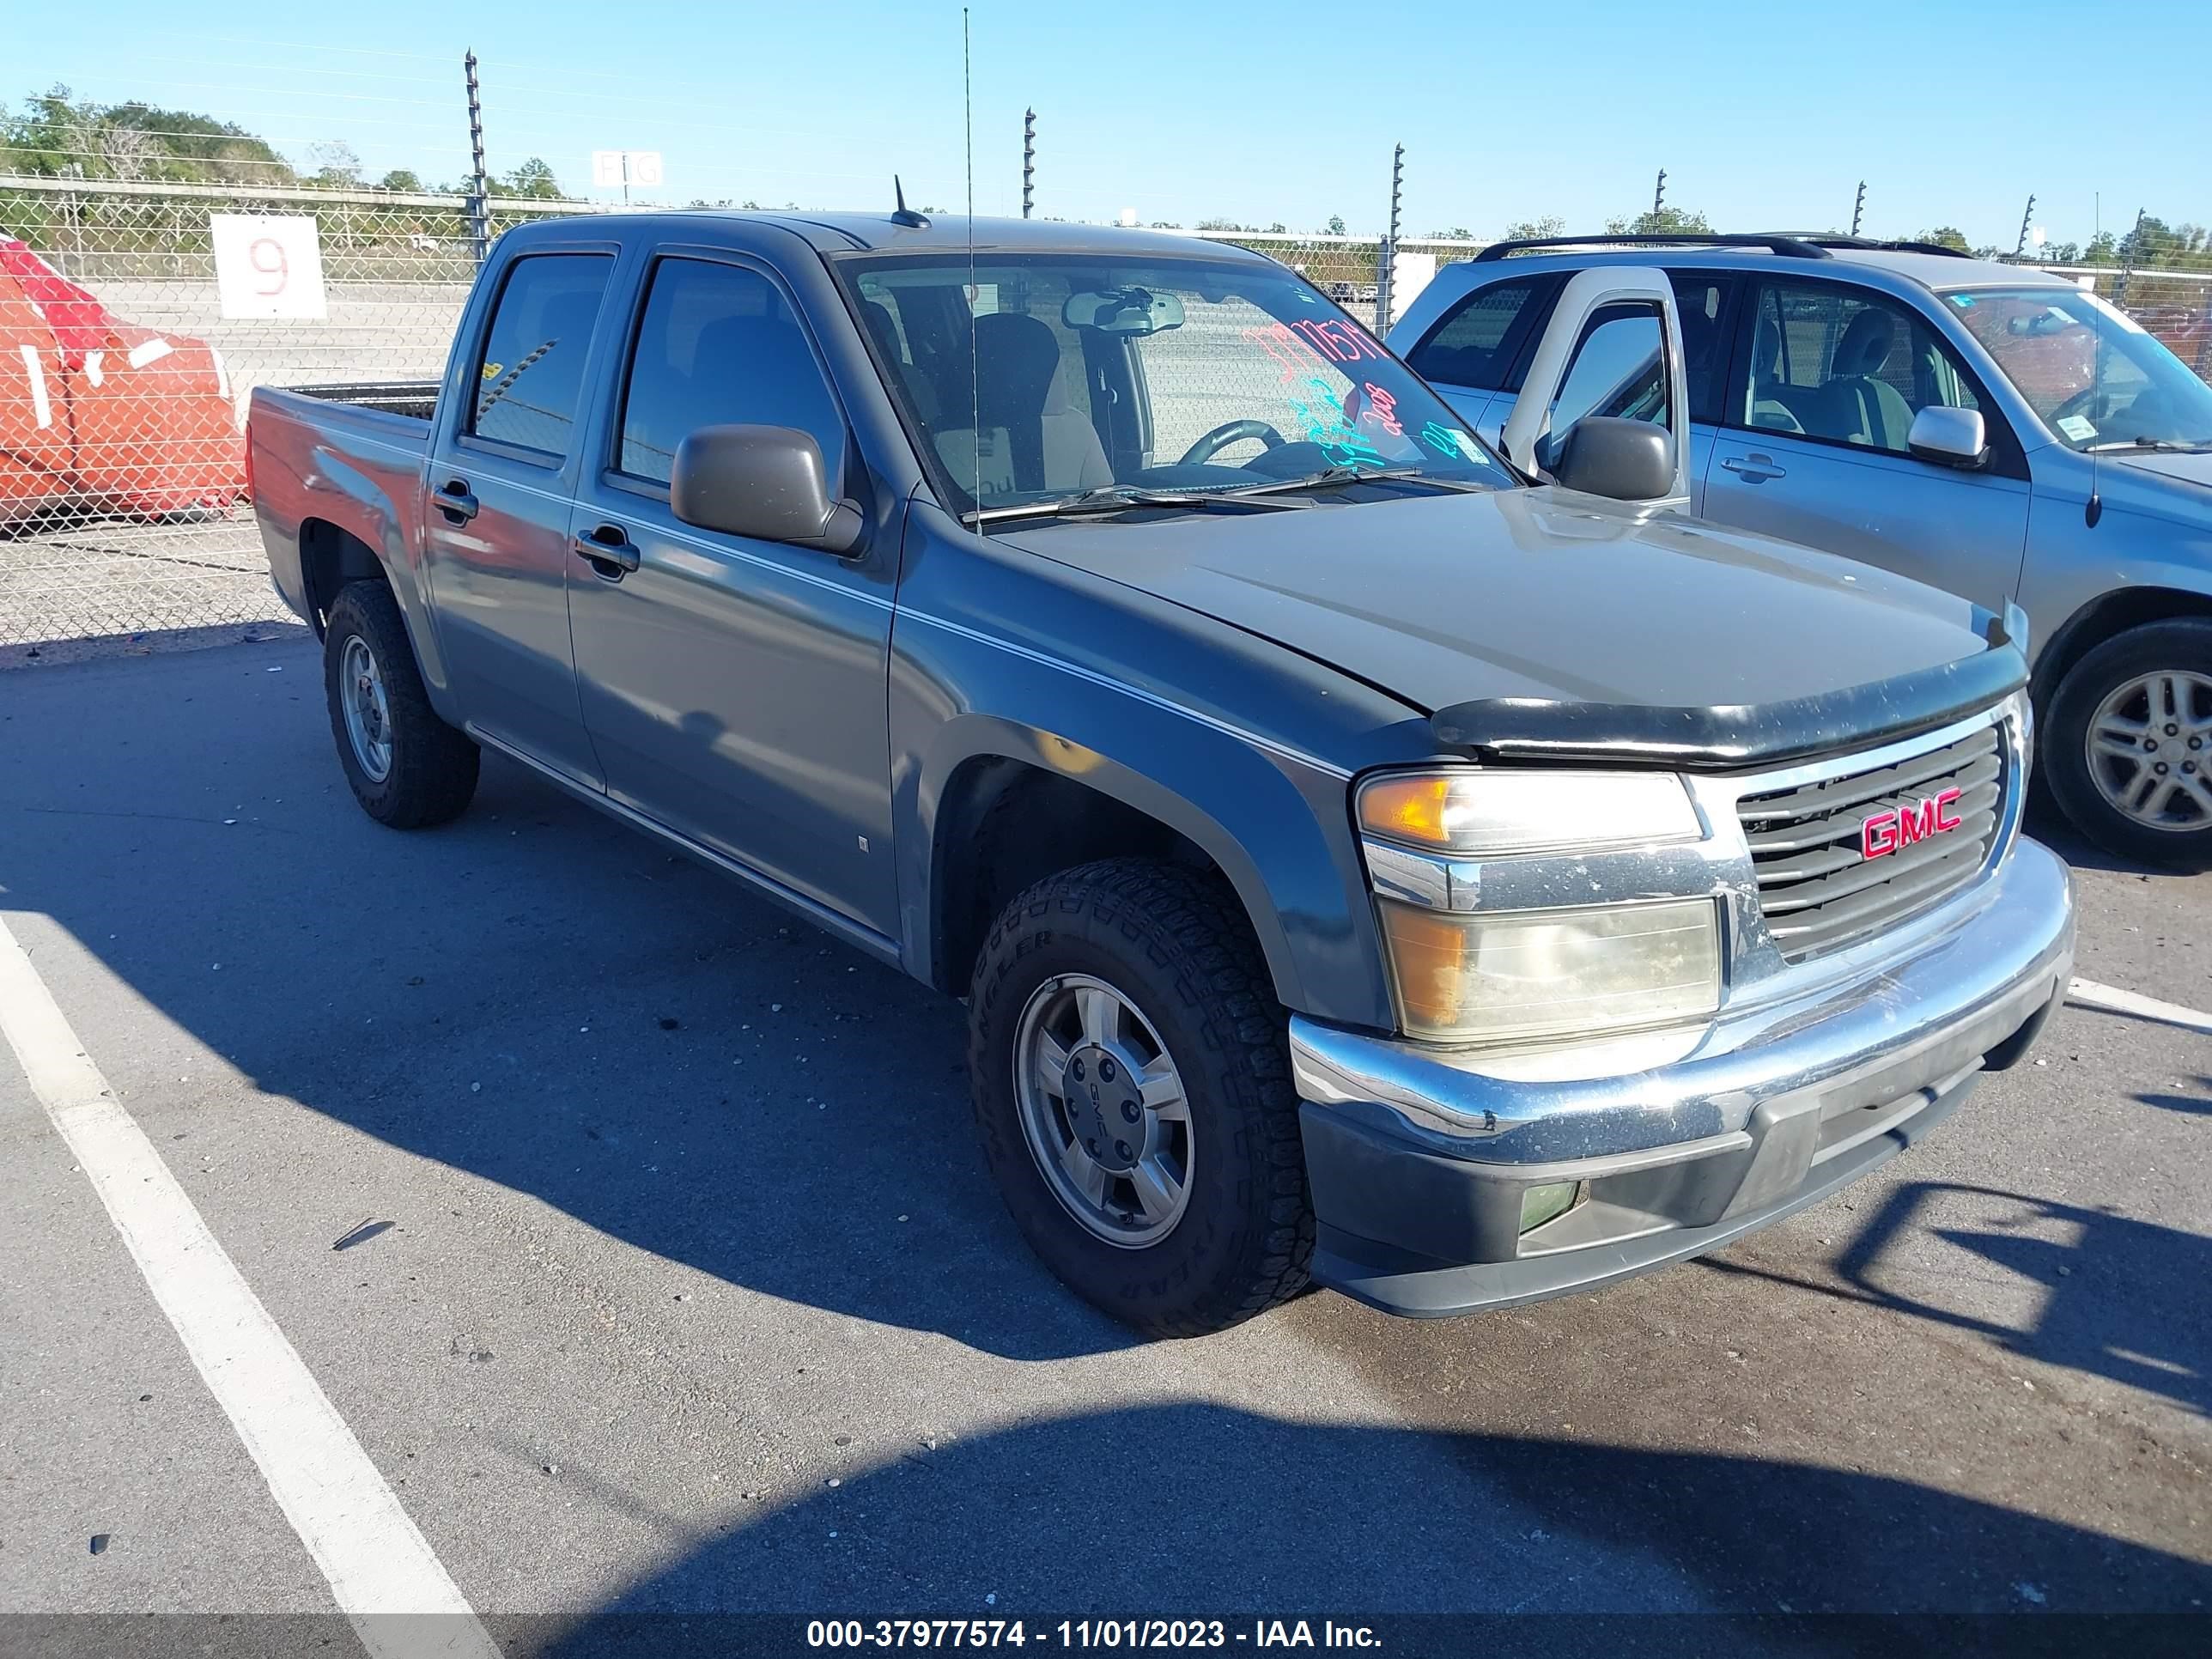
[969,858,1314,1336]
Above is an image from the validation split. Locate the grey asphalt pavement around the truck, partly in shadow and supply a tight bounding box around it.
[0,639,2212,1635]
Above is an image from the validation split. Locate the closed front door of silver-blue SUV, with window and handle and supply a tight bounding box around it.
[1704,276,2028,608]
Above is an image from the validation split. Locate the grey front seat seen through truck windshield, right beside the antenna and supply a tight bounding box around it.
[938,312,1113,491]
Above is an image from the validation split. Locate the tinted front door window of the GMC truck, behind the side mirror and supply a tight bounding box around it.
[615,258,845,495]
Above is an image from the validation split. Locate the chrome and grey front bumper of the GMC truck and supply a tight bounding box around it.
[1290,838,2075,1316]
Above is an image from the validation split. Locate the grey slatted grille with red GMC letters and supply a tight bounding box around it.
[1736,726,2006,963]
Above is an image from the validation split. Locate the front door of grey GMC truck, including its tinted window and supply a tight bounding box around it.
[568,243,898,936]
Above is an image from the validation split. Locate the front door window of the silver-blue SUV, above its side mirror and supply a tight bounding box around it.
[1729,283,1982,456]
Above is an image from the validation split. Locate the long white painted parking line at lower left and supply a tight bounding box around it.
[0,918,500,1659]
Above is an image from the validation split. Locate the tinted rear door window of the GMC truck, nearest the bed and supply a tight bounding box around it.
[469,254,615,456]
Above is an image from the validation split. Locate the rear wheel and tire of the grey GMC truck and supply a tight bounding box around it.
[323,581,480,830]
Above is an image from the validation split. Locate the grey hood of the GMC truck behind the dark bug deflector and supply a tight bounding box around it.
[998,489,1986,714]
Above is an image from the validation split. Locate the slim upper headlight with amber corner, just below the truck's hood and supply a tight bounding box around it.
[1360,769,1701,858]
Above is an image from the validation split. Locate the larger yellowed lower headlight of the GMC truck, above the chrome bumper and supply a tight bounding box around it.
[1378,898,1721,1042]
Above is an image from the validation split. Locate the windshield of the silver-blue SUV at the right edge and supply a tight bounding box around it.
[1944,288,2212,449]
